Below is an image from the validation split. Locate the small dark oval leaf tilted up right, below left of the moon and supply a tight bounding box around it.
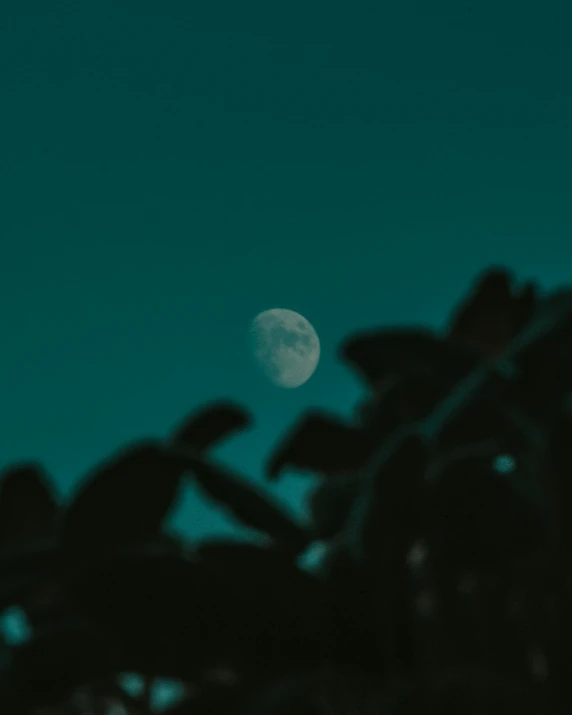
[171,402,250,451]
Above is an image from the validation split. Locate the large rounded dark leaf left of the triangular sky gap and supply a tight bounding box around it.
[63,442,187,552]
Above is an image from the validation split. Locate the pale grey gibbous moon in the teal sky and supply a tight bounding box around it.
[250,308,320,389]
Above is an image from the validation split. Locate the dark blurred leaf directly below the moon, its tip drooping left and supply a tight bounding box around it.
[267,412,373,479]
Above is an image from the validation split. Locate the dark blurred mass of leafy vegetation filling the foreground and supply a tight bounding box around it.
[0,270,572,715]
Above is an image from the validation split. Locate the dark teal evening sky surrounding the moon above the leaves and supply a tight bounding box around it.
[0,0,572,535]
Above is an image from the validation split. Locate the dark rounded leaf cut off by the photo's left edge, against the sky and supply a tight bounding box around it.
[0,463,58,545]
